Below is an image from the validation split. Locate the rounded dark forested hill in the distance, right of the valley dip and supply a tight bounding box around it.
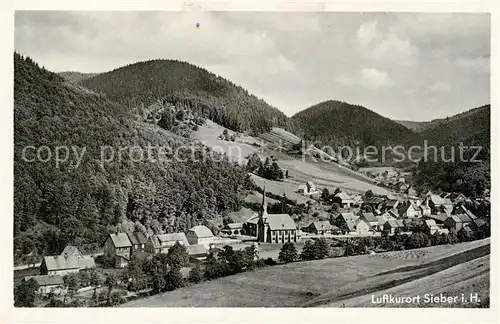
[290,100,421,148]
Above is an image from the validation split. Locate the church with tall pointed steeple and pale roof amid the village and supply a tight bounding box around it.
[257,189,300,243]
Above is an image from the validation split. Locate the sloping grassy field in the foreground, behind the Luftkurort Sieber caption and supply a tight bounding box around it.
[122,239,490,307]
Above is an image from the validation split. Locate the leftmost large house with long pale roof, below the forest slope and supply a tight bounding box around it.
[40,255,95,276]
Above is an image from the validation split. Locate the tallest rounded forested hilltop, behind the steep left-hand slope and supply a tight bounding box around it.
[80,60,287,133]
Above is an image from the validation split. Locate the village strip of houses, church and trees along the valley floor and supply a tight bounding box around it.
[16,156,490,306]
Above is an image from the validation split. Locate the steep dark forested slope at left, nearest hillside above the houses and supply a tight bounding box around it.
[14,54,248,261]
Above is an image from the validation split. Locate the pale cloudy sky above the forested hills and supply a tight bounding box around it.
[15,11,490,121]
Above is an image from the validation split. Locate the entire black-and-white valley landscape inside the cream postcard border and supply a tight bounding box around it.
[9,11,492,308]
